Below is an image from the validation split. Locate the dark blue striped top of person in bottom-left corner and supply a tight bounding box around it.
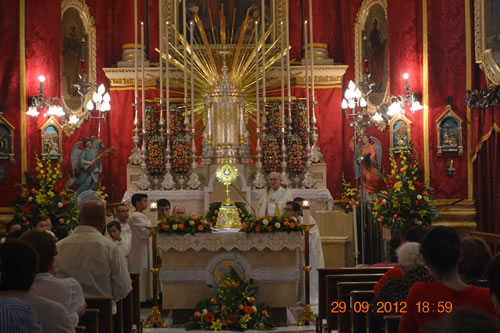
[0,297,42,333]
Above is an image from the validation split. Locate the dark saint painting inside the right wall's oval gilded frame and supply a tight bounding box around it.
[360,4,389,106]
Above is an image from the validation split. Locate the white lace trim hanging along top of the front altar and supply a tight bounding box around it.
[158,229,304,252]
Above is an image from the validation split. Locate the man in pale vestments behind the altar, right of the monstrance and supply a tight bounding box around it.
[257,172,293,217]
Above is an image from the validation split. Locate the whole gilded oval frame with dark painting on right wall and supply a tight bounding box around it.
[354,0,389,113]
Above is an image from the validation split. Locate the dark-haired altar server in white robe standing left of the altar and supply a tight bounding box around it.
[128,193,152,302]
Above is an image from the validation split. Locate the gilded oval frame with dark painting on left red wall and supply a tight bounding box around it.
[61,0,97,135]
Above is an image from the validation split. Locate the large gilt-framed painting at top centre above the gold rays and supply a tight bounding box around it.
[164,0,288,45]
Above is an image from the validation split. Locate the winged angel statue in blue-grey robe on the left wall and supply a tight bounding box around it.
[71,136,115,195]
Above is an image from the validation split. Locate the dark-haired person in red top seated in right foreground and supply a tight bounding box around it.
[399,226,495,333]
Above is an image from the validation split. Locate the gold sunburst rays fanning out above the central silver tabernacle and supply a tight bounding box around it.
[156,8,289,132]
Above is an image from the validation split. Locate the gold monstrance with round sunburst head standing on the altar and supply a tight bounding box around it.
[215,163,241,228]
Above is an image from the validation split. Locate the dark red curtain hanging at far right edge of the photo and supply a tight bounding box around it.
[474,126,500,233]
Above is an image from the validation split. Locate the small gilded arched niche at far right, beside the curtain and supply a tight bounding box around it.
[436,104,464,156]
